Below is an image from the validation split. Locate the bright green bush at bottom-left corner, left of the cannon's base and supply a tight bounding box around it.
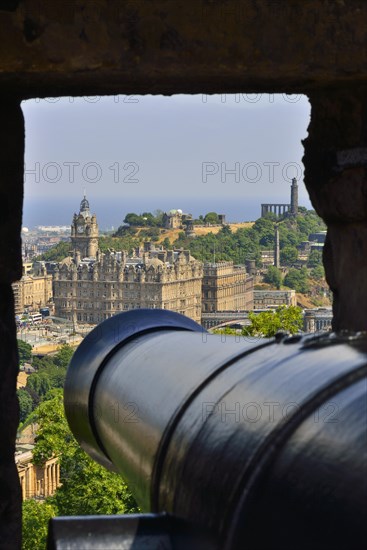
[22,500,56,550]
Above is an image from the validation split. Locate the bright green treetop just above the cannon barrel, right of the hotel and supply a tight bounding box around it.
[242,306,303,337]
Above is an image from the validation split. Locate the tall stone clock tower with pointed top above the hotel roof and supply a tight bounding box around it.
[71,193,98,258]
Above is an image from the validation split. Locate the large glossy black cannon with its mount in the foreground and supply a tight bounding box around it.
[48,309,367,550]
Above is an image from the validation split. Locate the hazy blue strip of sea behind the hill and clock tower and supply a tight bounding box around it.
[23,197,311,231]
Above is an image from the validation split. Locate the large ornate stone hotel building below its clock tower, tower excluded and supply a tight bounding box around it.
[54,250,203,323]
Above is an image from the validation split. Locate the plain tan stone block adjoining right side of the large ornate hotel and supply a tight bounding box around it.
[202,262,254,313]
